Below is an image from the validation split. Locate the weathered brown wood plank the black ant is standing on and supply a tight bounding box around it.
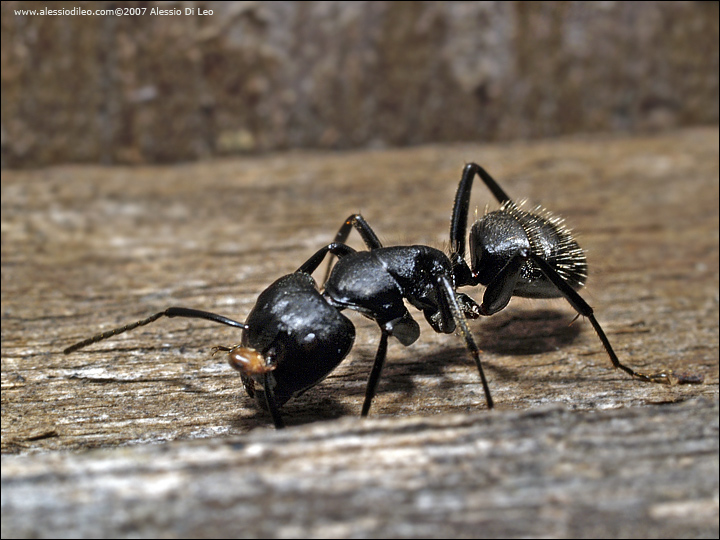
[2,129,718,452]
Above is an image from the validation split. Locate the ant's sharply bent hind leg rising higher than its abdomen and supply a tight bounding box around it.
[450,163,510,287]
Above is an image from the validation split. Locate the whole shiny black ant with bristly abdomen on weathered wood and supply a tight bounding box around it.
[64,163,670,428]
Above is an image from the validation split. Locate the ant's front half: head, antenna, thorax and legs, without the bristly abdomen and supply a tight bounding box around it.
[63,215,493,428]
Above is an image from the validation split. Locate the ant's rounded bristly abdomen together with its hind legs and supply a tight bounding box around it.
[450,163,671,384]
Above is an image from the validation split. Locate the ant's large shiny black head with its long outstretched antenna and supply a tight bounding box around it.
[63,244,355,428]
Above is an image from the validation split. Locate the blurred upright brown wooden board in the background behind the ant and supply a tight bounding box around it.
[1,1,719,168]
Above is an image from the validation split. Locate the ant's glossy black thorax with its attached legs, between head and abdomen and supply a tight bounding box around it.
[324,214,493,416]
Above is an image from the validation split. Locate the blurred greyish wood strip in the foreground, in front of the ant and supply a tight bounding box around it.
[2,401,719,538]
